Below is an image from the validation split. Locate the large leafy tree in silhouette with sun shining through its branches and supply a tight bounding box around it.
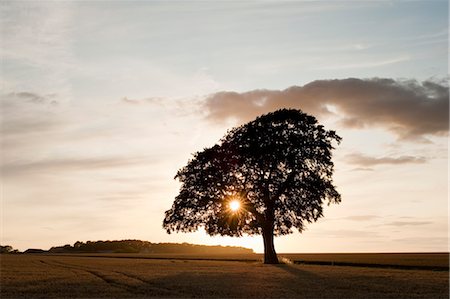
[163,109,341,263]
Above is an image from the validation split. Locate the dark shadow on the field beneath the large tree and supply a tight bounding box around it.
[134,264,321,298]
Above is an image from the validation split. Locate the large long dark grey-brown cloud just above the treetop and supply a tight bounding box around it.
[203,78,449,139]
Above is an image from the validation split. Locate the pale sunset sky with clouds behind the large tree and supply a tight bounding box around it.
[0,0,449,253]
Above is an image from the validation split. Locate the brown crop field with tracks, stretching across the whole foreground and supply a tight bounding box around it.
[0,254,449,298]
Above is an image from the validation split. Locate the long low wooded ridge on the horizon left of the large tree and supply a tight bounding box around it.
[48,240,253,254]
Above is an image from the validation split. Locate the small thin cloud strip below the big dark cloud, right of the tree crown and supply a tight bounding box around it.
[346,153,427,168]
